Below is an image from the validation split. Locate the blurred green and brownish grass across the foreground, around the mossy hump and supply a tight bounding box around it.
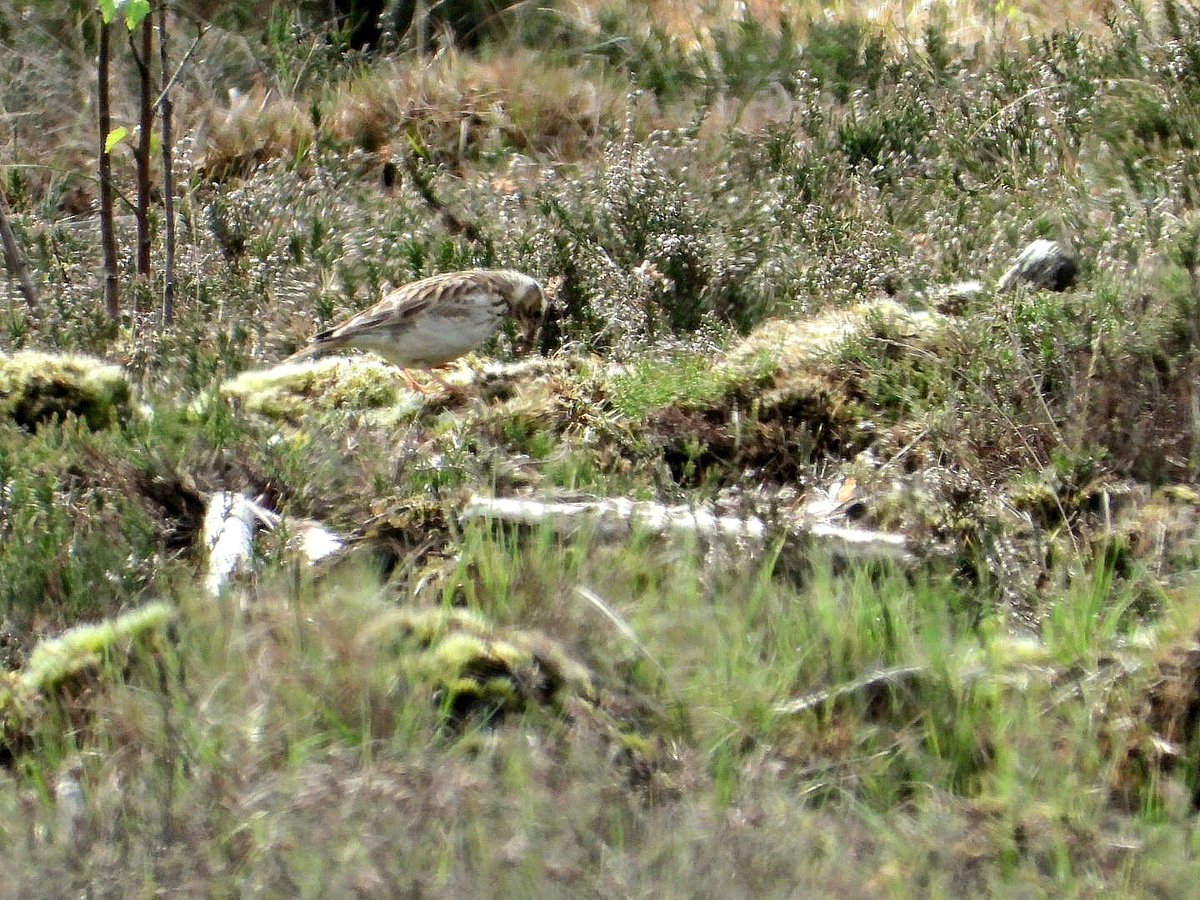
[0,529,1194,895]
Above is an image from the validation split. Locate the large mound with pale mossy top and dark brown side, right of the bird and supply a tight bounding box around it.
[612,300,947,484]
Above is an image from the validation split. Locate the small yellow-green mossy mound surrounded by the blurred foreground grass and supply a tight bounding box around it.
[362,607,594,721]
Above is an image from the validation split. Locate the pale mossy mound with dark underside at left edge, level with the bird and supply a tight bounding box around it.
[0,350,132,431]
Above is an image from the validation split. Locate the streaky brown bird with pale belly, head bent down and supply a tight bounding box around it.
[284,269,546,383]
